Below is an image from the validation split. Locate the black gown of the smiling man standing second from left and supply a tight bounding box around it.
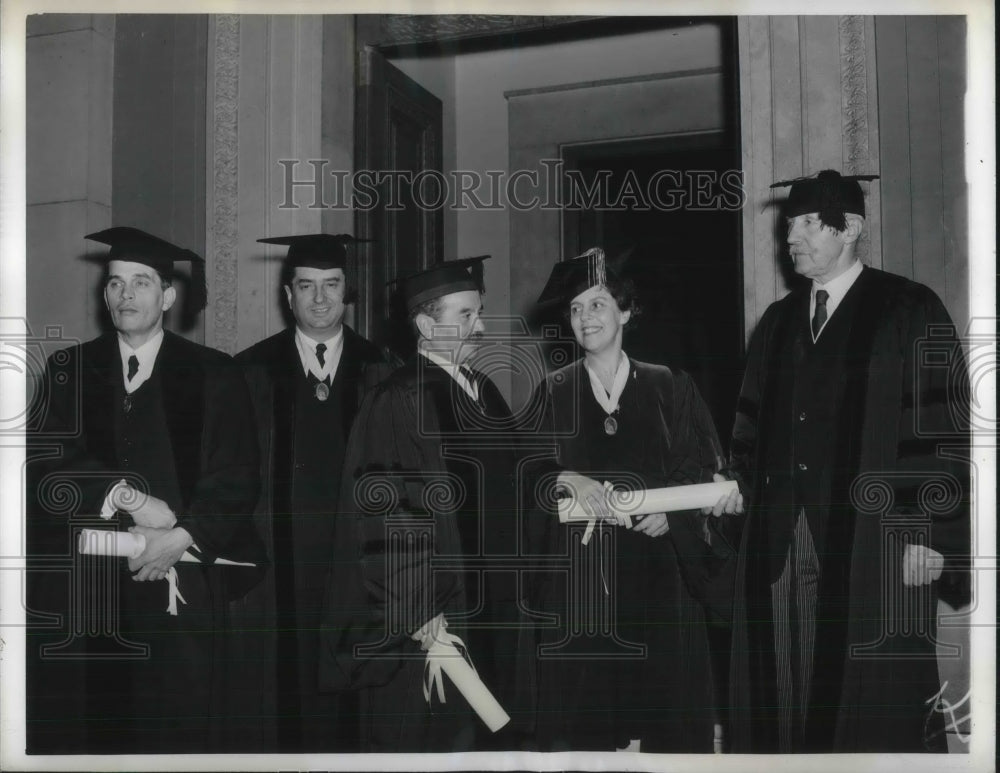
[236,326,389,752]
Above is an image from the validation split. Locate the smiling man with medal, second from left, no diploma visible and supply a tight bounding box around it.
[237,234,389,752]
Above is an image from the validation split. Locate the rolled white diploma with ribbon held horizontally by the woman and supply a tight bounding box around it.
[558,480,739,545]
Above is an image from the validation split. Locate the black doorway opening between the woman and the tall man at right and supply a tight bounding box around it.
[563,132,743,434]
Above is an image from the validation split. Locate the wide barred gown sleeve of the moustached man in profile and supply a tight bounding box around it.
[320,381,461,690]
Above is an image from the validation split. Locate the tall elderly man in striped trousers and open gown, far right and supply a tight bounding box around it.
[716,171,970,752]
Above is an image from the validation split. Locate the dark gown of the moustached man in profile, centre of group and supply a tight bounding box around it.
[323,355,526,752]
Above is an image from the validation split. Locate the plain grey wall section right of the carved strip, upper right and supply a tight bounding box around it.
[875,16,969,330]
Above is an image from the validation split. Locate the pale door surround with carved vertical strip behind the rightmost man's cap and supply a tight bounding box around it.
[738,16,882,339]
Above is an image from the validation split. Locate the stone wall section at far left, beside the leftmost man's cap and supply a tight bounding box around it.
[25,14,115,340]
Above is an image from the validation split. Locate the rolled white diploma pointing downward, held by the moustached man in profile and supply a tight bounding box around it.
[421,619,510,733]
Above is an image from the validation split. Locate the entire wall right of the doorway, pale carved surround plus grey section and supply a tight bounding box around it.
[739,16,969,337]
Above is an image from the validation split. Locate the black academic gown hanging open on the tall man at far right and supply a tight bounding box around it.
[730,268,969,752]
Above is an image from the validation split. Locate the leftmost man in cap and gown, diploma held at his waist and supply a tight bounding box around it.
[28,228,266,753]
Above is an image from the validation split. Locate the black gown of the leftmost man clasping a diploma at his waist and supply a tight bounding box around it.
[27,332,267,753]
